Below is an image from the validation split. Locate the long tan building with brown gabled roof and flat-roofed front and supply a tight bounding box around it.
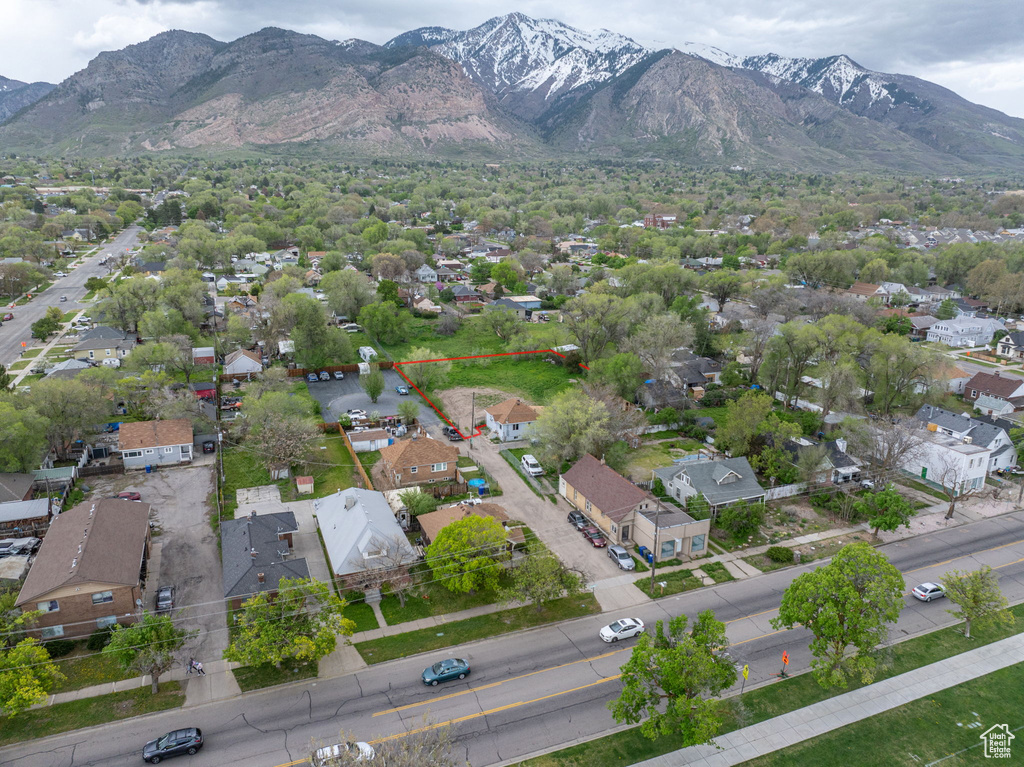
[558,455,711,561]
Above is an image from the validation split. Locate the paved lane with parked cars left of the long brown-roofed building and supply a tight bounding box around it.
[458,431,623,582]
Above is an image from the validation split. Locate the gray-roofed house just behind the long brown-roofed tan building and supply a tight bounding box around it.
[654,458,765,515]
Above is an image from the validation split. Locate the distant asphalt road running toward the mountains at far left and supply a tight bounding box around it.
[0,226,142,365]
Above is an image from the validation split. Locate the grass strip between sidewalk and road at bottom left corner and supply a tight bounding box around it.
[0,682,185,748]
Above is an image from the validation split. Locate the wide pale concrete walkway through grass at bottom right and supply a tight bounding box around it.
[635,634,1024,767]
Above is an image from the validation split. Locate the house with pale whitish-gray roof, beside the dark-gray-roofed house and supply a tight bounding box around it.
[313,487,419,583]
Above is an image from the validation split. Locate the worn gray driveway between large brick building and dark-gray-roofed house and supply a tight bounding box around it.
[90,462,227,663]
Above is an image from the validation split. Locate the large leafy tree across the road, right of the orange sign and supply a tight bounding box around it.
[771,543,904,687]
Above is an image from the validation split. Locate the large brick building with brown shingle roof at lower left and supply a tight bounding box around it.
[17,498,150,639]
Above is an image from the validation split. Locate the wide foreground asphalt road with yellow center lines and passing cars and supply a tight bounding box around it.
[8,505,1024,767]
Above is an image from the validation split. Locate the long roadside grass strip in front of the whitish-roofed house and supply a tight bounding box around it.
[355,594,601,665]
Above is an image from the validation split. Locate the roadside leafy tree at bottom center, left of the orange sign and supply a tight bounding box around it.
[608,610,736,747]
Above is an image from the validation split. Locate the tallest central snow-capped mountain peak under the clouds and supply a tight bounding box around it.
[385,13,653,118]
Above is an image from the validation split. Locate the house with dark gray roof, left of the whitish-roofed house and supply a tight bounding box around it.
[220,511,309,609]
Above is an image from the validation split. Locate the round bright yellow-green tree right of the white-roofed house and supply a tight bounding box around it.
[426,514,509,593]
